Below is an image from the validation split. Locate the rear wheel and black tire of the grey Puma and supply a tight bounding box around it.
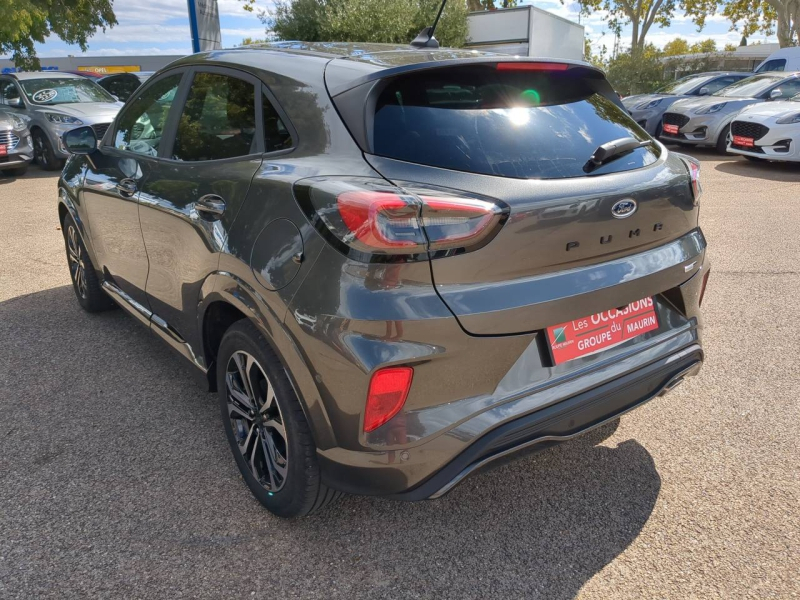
[217,319,342,518]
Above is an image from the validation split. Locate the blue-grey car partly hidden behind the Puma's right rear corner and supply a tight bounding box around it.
[622,71,752,137]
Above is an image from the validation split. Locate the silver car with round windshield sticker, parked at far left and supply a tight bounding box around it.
[0,71,122,171]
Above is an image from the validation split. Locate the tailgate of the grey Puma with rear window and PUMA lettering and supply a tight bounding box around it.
[328,59,699,335]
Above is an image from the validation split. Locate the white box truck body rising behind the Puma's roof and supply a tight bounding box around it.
[466,6,584,60]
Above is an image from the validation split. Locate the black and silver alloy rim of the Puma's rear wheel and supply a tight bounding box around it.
[225,351,289,493]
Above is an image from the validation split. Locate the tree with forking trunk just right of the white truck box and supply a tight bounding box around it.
[572,0,680,57]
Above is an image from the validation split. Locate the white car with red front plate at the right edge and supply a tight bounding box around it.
[728,94,800,161]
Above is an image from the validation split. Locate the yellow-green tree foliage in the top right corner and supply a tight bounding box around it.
[685,0,800,48]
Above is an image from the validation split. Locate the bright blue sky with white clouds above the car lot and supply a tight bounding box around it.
[9,0,775,57]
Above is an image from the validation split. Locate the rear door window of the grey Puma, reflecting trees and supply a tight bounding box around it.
[172,73,257,161]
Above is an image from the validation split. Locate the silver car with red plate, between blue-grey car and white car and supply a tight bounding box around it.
[660,71,800,154]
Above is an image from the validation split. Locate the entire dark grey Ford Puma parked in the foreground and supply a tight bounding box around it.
[58,42,709,517]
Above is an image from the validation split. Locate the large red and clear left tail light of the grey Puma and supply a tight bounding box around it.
[295,177,509,262]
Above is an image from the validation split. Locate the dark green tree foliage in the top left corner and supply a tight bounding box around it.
[0,0,117,70]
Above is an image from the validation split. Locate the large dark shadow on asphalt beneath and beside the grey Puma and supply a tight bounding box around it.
[0,286,661,599]
